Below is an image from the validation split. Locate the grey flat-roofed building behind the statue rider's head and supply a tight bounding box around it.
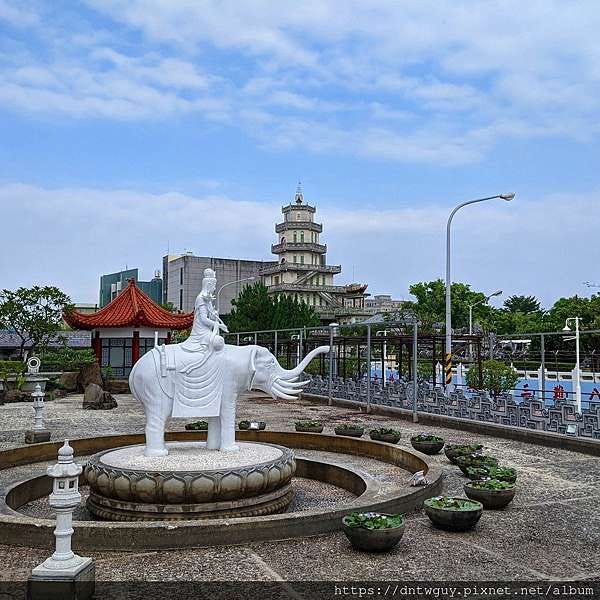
[163,253,271,315]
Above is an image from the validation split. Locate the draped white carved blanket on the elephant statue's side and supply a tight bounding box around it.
[153,344,224,417]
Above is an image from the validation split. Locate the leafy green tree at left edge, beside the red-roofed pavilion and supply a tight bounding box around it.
[0,285,73,358]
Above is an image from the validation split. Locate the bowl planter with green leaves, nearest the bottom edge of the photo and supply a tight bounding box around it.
[342,512,405,552]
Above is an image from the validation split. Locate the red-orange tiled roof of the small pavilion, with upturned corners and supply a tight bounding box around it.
[64,279,194,329]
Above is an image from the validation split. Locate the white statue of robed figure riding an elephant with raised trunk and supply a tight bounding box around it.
[129,269,329,456]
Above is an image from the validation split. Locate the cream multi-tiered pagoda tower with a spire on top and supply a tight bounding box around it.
[261,185,369,322]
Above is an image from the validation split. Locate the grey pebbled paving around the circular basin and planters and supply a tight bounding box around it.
[0,394,600,581]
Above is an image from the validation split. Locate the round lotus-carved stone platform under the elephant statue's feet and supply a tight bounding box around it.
[84,442,296,521]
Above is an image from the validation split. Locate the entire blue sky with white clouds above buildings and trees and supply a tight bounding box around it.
[0,0,600,304]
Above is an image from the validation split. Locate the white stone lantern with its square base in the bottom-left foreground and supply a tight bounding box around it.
[28,440,95,600]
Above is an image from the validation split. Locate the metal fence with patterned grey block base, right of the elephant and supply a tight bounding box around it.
[227,322,600,439]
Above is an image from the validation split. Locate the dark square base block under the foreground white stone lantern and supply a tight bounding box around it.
[27,558,96,600]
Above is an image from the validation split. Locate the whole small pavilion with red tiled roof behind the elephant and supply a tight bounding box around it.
[64,279,194,377]
